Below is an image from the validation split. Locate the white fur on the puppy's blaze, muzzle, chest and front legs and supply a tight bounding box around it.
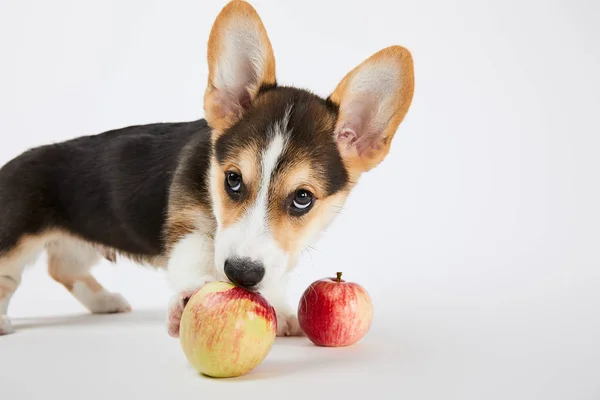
[179,107,301,336]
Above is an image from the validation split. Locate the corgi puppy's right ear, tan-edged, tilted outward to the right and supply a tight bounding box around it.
[329,46,414,174]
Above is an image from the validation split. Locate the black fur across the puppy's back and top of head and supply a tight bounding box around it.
[0,86,348,257]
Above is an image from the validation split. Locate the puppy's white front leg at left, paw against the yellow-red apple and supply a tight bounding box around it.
[167,232,217,338]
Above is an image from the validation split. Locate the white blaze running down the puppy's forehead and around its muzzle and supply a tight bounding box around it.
[215,113,290,288]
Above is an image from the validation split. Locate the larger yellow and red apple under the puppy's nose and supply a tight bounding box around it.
[179,282,277,378]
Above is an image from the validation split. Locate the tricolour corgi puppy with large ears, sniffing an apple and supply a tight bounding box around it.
[0,0,414,337]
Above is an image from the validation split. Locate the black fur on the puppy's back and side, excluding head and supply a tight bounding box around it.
[0,120,210,256]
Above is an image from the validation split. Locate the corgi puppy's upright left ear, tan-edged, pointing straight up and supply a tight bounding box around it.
[204,0,276,131]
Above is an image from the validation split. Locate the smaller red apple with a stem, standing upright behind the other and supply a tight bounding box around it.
[298,272,373,347]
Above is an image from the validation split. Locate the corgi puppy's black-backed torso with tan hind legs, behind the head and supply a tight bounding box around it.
[0,120,210,334]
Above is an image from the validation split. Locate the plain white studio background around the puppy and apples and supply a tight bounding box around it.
[0,0,600,400]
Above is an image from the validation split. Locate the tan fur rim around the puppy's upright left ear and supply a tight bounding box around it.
[204,0,276,134]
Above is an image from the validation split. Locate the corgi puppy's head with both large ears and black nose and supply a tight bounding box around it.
[204,1,413,289]
